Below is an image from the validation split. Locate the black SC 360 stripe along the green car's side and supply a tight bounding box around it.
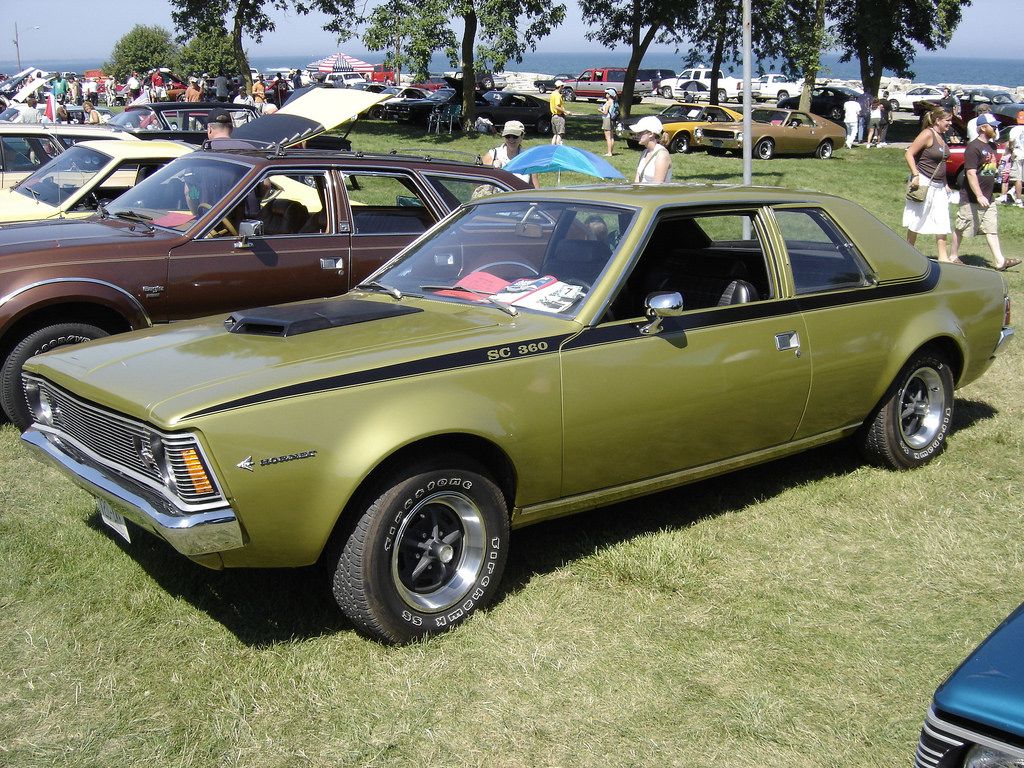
[183,262,939,419]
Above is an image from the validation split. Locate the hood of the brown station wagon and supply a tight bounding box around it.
[0,216,177,264]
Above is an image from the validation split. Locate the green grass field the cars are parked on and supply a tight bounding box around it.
[0,115,1024,768]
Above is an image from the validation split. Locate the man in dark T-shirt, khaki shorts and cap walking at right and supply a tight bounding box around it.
[949,112,1021,272]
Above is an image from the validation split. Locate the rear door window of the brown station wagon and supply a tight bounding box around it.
[345,173,434,234]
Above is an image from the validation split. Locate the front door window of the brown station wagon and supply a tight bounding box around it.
[207,171,328,238]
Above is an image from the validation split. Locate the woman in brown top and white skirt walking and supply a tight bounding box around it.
[903,109,959,262]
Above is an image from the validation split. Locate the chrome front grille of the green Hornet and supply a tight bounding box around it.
[25,376,223,505]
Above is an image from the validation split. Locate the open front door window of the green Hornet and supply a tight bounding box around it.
[610,213,772,319]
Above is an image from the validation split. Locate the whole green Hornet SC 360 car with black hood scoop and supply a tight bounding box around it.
[24,185,1013,641]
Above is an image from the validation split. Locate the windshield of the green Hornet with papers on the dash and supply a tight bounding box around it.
[372,201,636,317]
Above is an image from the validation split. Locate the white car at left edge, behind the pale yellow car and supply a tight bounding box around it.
[0,123,134,189]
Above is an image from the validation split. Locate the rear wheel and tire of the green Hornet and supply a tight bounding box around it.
[860,352,953,469]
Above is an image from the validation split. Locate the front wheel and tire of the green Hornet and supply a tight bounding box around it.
[332,458,509,643]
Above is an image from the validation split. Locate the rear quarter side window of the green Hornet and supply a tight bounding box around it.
[775,208,868,294]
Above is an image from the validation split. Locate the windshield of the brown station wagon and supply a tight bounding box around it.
[106,153,250,232]
